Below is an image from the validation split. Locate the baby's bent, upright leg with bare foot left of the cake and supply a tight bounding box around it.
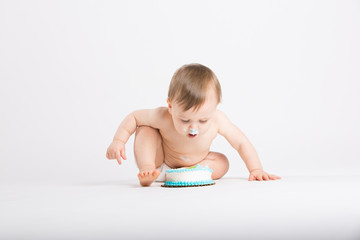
[134,126,164,186]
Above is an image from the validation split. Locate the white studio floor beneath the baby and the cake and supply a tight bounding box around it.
[0,175,360,240]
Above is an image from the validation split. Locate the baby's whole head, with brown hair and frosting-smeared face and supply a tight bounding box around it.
[167,64,221,138]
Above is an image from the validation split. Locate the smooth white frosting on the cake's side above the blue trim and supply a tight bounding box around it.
[165,170,212,182]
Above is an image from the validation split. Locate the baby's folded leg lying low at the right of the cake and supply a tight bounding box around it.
[199,152,229,179]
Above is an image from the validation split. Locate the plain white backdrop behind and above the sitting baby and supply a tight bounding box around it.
[0,0,360,183]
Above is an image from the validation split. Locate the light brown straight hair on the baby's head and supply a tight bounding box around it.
[168,63,221,111]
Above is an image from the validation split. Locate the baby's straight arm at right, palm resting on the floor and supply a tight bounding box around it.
[217,110,280,181]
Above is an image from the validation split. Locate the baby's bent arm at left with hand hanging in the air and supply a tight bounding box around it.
[106,108,161,164]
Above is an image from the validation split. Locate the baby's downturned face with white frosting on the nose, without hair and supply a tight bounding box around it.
[169,90,218,139]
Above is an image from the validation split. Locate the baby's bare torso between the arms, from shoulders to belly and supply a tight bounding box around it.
[159,108,218,168]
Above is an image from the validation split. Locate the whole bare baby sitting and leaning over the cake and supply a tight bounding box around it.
[106,64,280,186]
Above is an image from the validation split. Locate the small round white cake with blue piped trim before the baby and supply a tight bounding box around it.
[161,164,215,187]
